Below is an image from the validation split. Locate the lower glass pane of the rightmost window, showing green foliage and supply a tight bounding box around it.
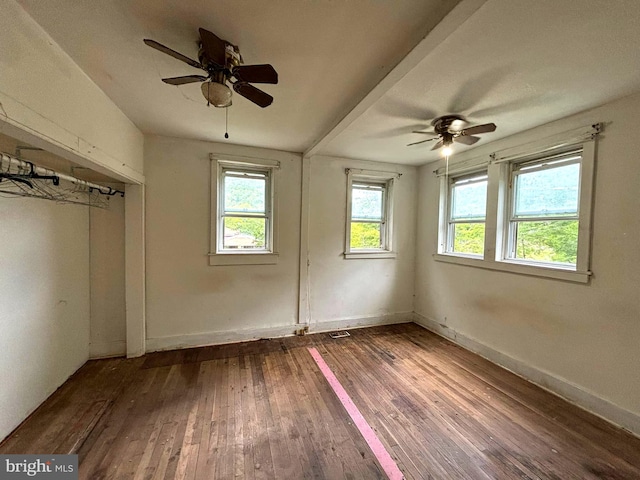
[514,220,578,265]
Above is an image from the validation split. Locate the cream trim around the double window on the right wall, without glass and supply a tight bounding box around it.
[433,124,601,283]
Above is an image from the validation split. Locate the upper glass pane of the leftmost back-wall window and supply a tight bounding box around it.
[224,174,267,213]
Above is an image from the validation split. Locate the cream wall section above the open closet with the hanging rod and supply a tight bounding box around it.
[0,0,144,182]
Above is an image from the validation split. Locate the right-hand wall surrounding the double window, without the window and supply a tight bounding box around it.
[416,95,640,433]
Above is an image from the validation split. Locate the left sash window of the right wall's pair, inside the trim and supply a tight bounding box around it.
[445,172,488,257]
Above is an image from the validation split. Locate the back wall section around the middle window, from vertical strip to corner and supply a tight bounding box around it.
[309,156,417,330]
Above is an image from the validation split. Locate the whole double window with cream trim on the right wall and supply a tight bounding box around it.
[434,124,600,283]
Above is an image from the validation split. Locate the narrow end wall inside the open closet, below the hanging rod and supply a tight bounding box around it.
[89,193,126,358]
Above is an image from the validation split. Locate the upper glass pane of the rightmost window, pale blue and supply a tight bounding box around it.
[514,163,580,217]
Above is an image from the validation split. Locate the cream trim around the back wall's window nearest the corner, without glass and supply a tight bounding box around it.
[344,168,402,259]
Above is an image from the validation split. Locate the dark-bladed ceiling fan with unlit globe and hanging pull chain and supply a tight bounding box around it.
[144,28,278,108]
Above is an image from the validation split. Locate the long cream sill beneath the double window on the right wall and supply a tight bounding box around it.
[433,253,591,283]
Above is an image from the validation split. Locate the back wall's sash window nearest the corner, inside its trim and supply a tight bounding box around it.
[349,180,389,251]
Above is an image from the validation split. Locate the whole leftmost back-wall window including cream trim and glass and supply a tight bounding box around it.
[209,155,278,265]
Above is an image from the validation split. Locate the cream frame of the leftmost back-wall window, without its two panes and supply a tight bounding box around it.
[208,154,280,266]
